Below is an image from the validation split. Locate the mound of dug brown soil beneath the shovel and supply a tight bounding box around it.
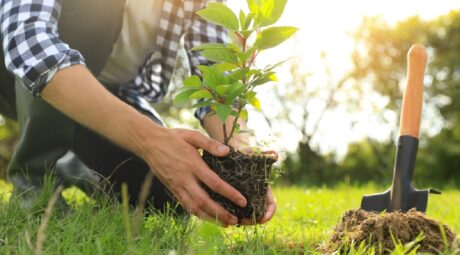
[326,209,457,254]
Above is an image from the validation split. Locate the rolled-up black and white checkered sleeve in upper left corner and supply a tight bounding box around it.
[0,0,85,96]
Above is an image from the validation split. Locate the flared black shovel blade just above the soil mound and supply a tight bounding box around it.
[361,187,438,212]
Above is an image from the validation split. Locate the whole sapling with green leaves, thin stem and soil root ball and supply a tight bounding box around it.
[174,0,297,218]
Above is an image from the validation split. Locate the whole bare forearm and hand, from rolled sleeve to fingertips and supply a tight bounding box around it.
[42,65,247,226]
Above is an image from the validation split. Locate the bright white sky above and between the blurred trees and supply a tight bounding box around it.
[229,0,460,156]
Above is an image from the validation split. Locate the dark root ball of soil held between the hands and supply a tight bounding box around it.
[203,150,276,221]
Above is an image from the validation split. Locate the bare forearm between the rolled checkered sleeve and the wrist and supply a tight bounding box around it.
[42,65,164,157]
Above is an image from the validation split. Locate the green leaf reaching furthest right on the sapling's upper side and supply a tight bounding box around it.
[255,26,298,50]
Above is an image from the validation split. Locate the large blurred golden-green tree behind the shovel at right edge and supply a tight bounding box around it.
[341,10,460,184]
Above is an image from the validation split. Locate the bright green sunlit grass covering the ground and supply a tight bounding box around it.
[0,181,460,254]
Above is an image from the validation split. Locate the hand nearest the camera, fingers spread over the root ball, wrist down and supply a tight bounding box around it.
[143,128,247,226]
